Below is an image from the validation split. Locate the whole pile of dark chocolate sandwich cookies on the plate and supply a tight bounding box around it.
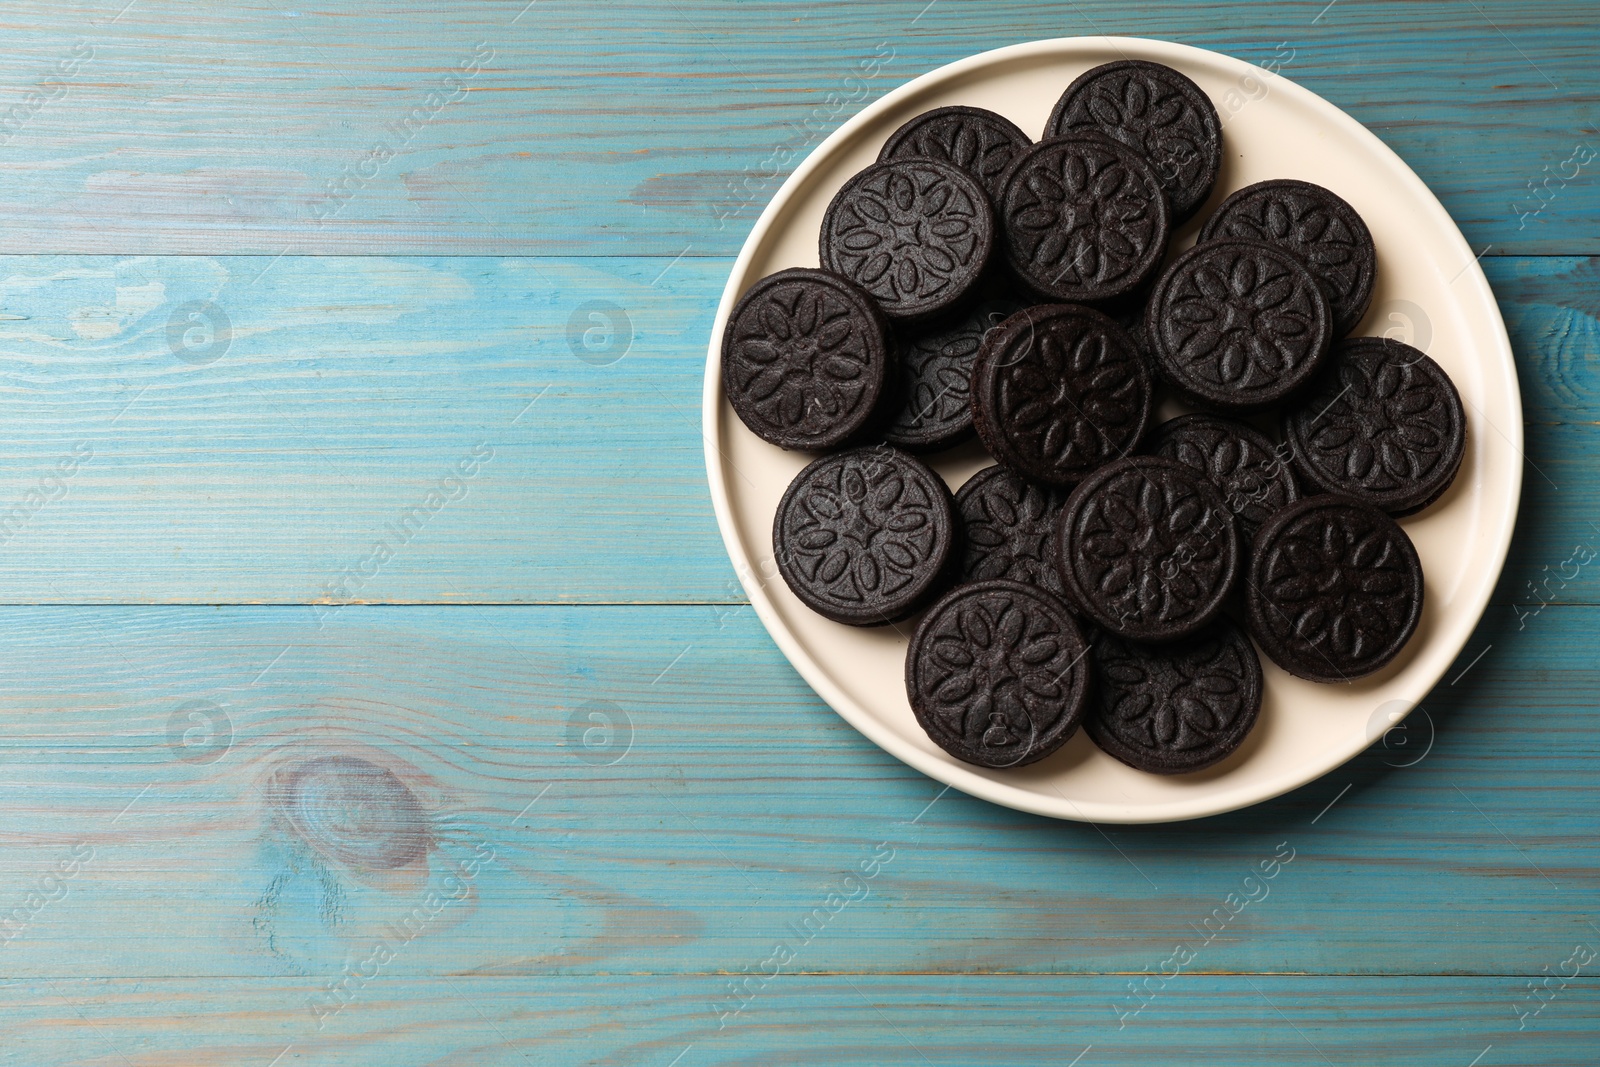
[723,61,1466,774]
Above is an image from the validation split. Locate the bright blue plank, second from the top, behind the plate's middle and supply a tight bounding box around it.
[0,256,1600,609]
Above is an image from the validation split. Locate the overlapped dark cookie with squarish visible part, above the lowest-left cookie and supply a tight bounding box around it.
[955,466,1067,597]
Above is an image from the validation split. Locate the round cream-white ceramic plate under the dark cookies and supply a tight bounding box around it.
[704,37,1522,822]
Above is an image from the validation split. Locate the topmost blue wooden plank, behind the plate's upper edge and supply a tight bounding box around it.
[0,0,1600,256]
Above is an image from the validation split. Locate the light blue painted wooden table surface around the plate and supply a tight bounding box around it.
[0,0,1600,1067]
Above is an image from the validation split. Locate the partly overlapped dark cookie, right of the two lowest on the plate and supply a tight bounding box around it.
[1083,619,1261,774]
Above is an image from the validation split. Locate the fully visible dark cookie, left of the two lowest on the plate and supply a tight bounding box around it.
[906,581,1088,768]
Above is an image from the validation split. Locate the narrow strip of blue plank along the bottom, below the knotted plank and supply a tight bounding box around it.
[0,979,1600,1067]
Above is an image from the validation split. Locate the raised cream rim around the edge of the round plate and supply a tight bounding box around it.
[701,35,1523,824]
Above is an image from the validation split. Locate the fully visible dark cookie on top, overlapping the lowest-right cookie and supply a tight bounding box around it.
[1056,456,1240,641]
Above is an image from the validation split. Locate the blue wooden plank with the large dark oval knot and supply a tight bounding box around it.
[0,606,1600,977]
